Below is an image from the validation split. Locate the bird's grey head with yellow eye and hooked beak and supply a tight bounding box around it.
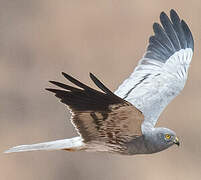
[144,127,180,153]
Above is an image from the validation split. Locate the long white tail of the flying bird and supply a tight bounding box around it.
[5,137,85,153]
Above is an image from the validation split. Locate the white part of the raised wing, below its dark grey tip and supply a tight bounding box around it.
[115,48,193,127]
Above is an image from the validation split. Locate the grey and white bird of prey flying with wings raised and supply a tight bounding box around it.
[6,10,194,155]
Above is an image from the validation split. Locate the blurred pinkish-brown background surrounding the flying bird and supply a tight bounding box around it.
[0,0,201,180]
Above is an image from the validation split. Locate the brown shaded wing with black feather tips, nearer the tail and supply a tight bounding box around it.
[47,73,144,150]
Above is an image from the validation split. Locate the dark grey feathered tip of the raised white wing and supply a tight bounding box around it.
[144,9,194,63]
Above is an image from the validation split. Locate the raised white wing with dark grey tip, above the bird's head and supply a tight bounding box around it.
[115,10,194,126]
